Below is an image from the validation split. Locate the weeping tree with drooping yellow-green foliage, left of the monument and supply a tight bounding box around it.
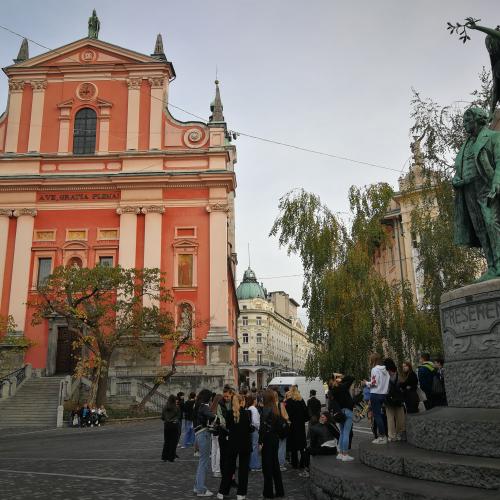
[270,183,436,379]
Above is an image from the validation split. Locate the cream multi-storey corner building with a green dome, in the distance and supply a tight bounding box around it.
[236,268,311,388]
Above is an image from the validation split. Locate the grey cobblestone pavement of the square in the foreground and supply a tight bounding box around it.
[0,420,350,500]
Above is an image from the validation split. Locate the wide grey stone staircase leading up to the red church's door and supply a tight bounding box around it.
[0,377,64,427]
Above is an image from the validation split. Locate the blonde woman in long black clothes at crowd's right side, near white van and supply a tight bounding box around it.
[286,386,309,469]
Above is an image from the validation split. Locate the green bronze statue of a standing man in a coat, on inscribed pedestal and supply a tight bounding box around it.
[452,108,500,281]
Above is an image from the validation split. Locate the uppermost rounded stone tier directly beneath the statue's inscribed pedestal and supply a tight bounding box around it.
[406,407,500,458]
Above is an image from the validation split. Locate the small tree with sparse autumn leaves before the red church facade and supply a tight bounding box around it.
[30,266,195,405]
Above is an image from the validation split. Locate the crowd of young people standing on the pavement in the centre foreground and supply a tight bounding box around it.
[162,386,332,500]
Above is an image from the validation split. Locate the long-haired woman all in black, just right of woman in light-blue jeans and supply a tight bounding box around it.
[218,394,253,498]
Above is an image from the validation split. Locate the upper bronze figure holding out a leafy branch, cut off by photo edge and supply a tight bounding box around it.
[448,17,500,116]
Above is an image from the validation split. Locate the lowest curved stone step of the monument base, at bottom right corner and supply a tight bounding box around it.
[308,456,498,500]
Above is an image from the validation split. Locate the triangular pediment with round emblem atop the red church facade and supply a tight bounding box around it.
[8,38,159,68]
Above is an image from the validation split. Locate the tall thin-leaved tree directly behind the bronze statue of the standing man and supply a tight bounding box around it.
[405,68,492,318]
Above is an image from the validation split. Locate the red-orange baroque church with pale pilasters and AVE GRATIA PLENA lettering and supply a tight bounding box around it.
[0,21,238,390]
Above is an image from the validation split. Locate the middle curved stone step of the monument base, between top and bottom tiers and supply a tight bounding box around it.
[359,442,500,488]
